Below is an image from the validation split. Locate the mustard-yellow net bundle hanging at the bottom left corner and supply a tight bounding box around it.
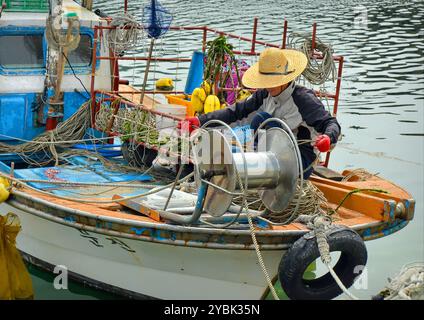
[0,213,34,300]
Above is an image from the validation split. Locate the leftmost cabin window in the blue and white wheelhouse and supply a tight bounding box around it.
[0,34,44,69]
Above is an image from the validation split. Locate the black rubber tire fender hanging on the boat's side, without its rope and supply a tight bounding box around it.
[278,226,368,300]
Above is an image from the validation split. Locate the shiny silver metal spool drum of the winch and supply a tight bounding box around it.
[193,119,301,217]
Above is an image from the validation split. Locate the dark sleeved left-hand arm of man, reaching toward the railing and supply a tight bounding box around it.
[199,90,268,125]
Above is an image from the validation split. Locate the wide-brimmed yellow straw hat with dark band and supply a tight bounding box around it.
[242,48,308,89]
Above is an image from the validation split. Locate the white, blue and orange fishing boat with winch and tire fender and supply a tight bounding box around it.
[0,0,414,299]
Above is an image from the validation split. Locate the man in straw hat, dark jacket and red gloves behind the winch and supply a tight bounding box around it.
[181,48,340,179]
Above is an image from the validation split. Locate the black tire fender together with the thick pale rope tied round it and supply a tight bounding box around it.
[279,213,367,300]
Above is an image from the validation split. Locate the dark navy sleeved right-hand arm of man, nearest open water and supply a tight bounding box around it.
[293,87,341,144]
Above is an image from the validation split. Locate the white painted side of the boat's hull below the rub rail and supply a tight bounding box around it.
[0,203,283,299]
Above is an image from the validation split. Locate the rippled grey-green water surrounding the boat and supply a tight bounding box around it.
[31,0,424,299]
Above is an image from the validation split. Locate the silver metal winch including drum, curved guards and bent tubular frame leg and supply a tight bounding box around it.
[160,118,303,224]
